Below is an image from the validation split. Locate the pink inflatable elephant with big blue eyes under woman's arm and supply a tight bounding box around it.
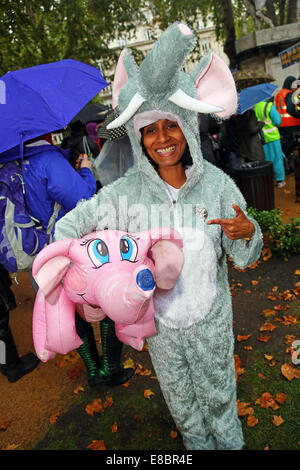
[32,228,183,362]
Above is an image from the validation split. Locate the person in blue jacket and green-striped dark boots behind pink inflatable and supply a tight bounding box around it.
[1,134,133,386]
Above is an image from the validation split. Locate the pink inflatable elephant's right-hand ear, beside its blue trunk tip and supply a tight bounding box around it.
[150,228,184,290]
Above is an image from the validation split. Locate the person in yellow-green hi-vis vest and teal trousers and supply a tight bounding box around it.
[254,100,286,188]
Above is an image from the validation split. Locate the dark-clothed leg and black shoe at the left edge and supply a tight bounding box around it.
[0,264,40,383]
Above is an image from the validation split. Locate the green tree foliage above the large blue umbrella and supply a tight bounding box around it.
[0,0,143,74]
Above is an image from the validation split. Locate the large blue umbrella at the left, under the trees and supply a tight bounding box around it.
[0,59,108,157]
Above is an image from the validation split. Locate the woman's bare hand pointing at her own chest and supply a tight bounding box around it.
[206,204,254,240]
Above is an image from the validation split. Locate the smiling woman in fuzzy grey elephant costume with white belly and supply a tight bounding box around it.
[55,22,262,450]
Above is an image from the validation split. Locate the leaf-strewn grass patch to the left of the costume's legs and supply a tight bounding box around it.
[35,380,184,450]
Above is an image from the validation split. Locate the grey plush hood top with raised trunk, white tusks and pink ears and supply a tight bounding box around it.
[107,22,237,129]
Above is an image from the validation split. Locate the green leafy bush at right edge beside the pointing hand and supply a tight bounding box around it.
[248,207,300,257]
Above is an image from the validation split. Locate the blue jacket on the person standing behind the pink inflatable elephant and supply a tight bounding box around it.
[1,144,97,228]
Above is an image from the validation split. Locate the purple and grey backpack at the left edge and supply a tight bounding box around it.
[0,160,60,273]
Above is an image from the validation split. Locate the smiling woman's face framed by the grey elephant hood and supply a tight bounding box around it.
[143,119,186,168]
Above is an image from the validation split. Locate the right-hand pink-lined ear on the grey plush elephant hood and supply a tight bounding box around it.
[190,52,238,118]
